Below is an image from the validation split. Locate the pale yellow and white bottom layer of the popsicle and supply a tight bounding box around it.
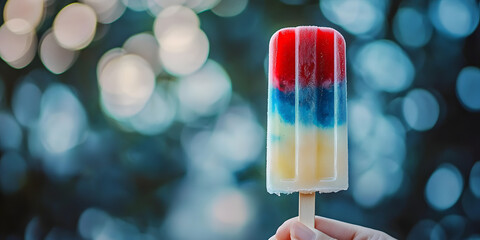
[267,114,348,193]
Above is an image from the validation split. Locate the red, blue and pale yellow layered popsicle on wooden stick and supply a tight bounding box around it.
[267,26,348,227]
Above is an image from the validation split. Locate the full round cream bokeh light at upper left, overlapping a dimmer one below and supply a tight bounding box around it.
[53,3,97,50]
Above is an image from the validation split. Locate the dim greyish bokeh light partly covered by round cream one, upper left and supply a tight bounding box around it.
[39,31,77,74]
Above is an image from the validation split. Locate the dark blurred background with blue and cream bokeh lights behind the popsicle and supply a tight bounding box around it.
[0,0,480,240]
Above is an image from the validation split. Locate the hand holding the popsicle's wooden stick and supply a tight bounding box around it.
[269,216,394,240]
